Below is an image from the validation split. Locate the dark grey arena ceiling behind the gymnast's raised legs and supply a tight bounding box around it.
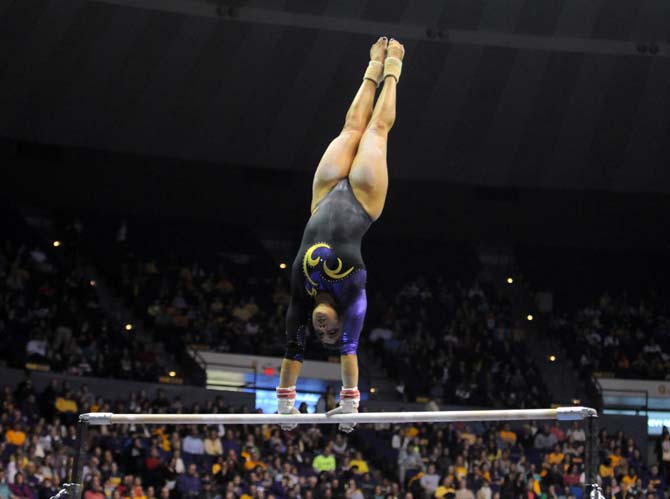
[0,0,670,193]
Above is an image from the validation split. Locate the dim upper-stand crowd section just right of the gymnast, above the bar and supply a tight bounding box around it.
[368,277,548,408]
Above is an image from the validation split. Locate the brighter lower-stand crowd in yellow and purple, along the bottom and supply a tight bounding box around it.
[0,378,670,499]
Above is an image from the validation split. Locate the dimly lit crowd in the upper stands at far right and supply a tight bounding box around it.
[551,293,670,380]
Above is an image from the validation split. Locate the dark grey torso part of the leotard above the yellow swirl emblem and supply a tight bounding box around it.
[296,178,372,268]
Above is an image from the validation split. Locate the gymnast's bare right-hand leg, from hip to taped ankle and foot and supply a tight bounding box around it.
[349,39,405,220]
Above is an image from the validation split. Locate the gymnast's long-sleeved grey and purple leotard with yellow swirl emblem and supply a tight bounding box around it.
[285,179,372,361]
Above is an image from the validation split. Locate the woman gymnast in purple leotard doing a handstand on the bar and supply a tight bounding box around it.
[277,37,405,433]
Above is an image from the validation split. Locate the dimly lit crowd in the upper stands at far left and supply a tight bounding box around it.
[0,239,169,380]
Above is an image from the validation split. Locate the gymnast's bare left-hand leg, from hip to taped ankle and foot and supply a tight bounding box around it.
[311,37,388,212]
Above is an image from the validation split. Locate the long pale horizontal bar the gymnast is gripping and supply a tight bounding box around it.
[79,407,598,425]
